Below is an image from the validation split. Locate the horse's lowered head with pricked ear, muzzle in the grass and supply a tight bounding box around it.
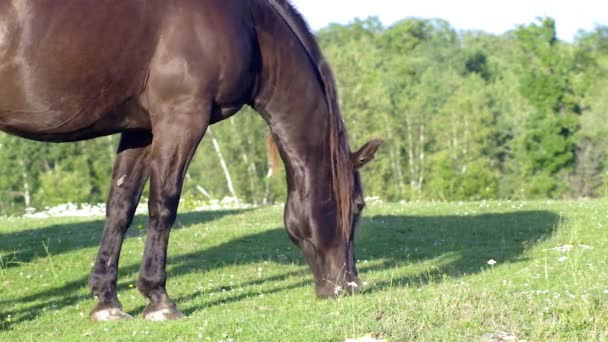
[285,139,383,298]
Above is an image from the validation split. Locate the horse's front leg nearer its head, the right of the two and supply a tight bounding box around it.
[137,106,209,320]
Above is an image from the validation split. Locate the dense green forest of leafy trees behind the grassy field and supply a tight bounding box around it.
[0,18,608,215]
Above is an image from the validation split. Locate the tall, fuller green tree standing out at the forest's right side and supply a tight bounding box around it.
[515,18,581,197]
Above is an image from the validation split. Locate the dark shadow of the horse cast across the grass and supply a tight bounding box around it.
[0,207,559,329]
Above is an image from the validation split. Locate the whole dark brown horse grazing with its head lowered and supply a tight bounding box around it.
[0,0,381,320]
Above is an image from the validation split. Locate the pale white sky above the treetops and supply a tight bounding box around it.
[292,0,608,41]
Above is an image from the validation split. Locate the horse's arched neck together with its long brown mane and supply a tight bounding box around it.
[251,0,354,232]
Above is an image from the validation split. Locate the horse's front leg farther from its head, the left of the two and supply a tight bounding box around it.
[89,132,152,321]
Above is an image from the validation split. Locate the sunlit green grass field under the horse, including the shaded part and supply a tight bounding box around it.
[0,200,608,341]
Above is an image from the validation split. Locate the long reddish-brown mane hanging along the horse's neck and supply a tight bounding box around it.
[267,0,354,237]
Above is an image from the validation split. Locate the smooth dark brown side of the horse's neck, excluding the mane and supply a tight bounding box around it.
[253,0,329,172]
